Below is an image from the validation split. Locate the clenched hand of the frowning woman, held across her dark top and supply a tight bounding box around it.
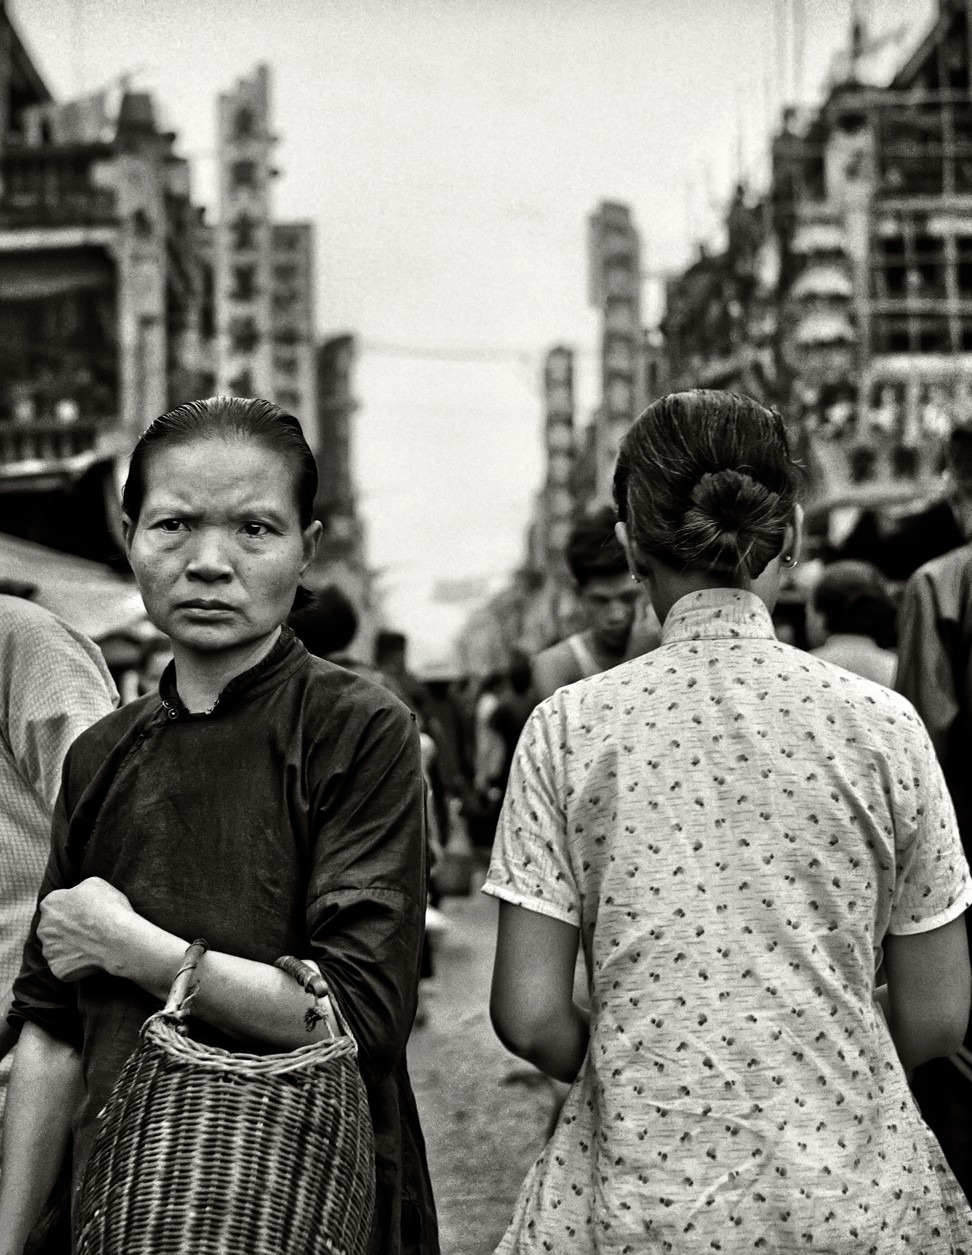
[38,876,139,980]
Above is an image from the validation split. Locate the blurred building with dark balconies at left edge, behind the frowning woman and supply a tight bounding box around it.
[0,5,212,557]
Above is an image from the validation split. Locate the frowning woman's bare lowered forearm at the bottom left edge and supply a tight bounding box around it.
[0,1024,82,1255]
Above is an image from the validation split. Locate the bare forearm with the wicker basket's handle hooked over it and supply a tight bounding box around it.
[110,916,327,1050]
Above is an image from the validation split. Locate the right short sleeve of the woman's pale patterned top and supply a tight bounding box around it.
[888,718,972,935]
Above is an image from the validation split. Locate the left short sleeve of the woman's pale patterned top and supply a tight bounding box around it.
[483,698,581,927]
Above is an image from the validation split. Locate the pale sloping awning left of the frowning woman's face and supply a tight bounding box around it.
[0,535,147,640]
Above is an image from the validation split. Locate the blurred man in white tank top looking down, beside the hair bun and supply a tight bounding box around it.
[533,506,660,702]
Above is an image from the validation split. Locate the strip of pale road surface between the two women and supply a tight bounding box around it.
[409,894,553,1255]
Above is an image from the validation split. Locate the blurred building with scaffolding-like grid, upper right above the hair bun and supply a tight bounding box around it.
[663,0,972,509]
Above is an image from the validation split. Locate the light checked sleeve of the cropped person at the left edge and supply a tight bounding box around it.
[3,614,118,811]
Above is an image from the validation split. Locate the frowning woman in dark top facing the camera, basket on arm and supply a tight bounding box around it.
[0,398,438,1255]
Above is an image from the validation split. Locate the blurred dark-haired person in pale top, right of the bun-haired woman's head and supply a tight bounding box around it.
[808,561,898,689]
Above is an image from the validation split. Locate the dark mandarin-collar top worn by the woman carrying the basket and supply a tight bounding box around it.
[11,628,439,1255]
